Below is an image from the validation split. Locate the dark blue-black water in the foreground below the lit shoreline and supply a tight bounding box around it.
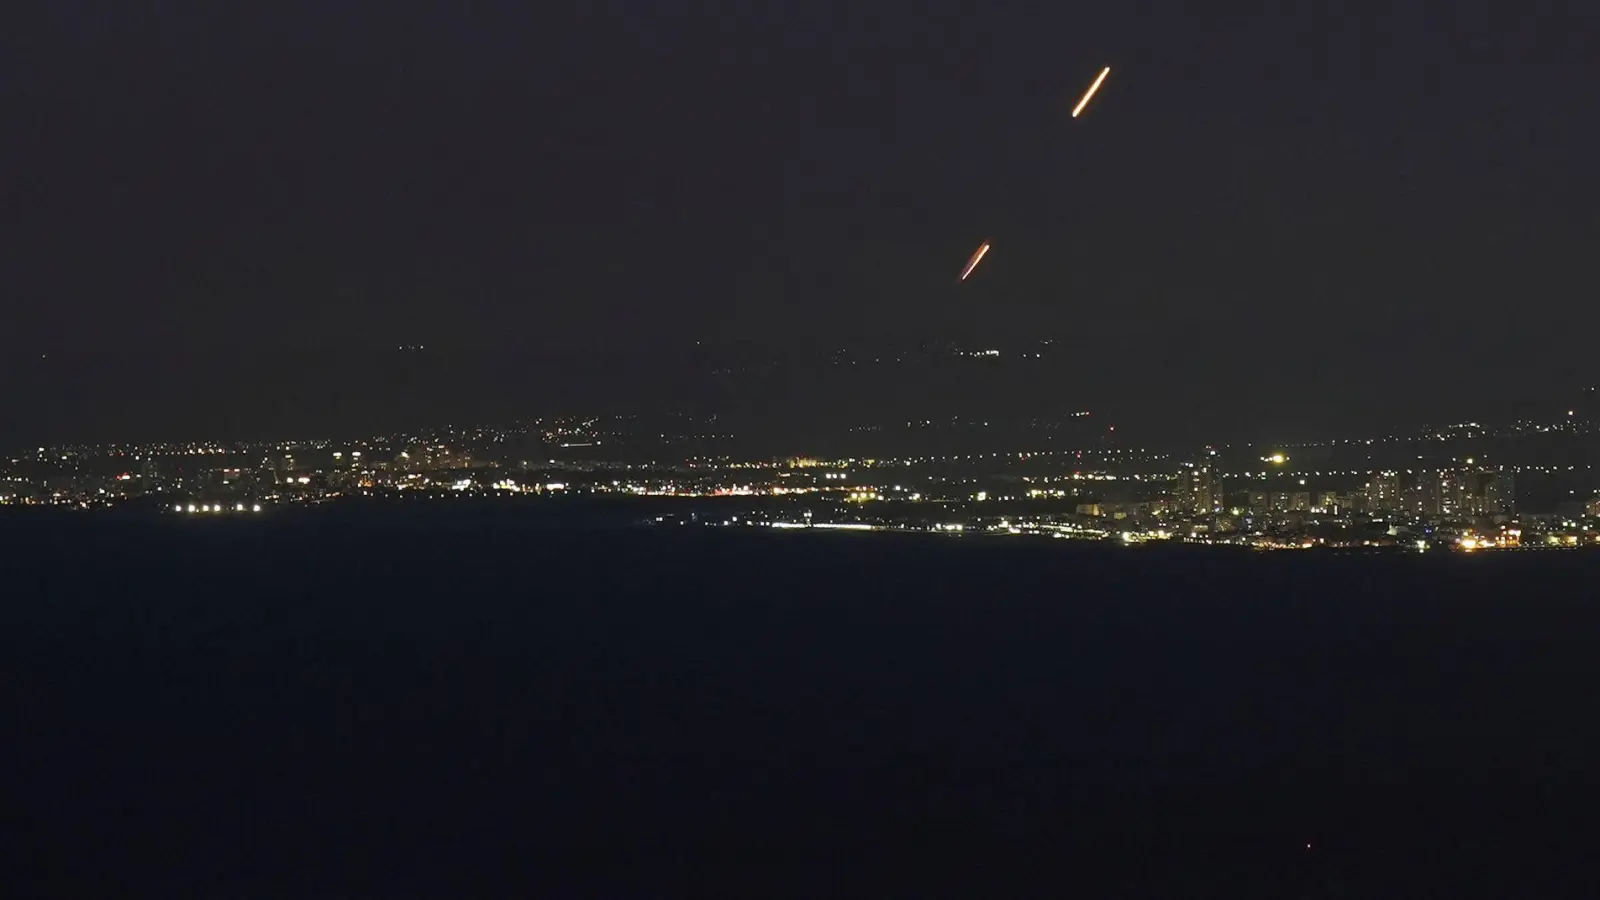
[0,512,1600,897]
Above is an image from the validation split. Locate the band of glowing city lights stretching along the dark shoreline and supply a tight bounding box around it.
[0,406,1600,554]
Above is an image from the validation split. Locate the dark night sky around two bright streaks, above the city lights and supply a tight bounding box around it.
[0,0,1600,441]
